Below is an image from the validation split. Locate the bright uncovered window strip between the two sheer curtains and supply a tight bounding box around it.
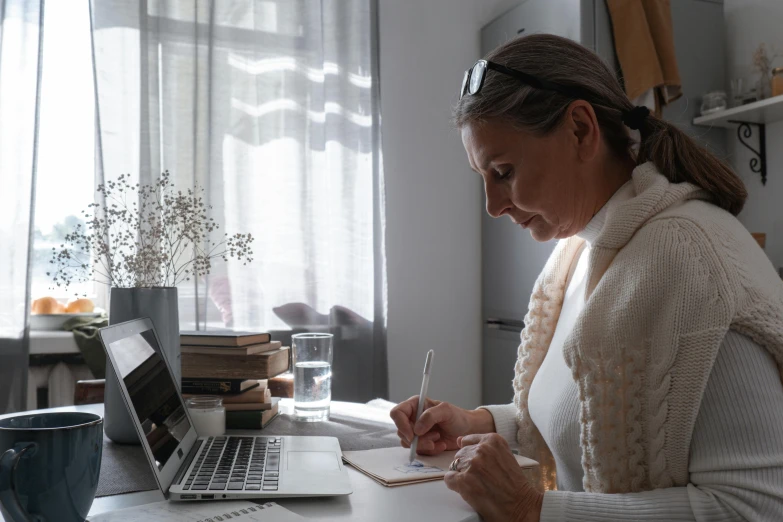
[32,0,103,305]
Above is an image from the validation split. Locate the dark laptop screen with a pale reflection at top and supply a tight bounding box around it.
[106,330,190,471]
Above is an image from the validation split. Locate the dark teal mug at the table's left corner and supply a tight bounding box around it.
[0,411,103,522]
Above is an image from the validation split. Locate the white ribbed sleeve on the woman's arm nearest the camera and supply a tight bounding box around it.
[541,331,783,522]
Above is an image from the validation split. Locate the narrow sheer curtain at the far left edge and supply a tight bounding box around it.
[0,0,43,413]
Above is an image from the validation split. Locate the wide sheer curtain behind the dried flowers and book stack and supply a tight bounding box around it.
[92,0,388,400]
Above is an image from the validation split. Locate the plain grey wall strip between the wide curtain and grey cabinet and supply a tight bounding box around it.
[379,0,482,407]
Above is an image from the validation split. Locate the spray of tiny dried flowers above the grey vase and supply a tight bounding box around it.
[47,171,254,288]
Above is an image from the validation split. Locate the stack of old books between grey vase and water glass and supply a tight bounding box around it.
[180,332,290,429]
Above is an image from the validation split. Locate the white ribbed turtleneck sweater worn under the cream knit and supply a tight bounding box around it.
[485,182,783,522]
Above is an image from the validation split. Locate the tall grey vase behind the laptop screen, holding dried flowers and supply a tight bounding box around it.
[103,287,182,444]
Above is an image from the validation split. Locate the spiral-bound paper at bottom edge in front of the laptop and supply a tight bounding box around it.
[87,500,307,522]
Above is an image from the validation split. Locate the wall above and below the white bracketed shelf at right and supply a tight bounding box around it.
[724,0,783,267]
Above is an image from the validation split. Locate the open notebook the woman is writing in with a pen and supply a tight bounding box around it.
[343,446,538,487]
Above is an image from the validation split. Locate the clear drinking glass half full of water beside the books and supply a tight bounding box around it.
[291,333,334,422]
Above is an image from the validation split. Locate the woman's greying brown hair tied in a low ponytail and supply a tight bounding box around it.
[454,34,747,215]
